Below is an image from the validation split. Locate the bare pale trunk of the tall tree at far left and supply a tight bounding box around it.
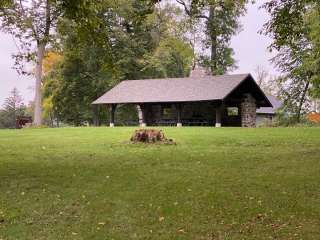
[33,42,45,126]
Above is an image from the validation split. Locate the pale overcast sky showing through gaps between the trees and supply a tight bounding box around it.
[0,0,276,106]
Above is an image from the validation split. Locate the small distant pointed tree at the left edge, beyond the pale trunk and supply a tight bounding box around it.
[0,88,26,128]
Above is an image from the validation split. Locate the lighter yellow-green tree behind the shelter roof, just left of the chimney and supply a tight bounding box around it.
[143,4,194,78]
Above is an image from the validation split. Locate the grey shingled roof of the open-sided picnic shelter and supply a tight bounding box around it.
[93,74,268,107]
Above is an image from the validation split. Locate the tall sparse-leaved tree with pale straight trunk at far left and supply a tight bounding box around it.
[0,0,62,125]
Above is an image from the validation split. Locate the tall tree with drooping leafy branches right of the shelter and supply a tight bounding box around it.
[263,0,319,122]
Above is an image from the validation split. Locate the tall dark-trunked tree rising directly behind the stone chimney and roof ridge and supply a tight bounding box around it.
[176,0,248,75]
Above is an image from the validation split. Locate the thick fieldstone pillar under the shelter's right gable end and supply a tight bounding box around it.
[240,94,257,127]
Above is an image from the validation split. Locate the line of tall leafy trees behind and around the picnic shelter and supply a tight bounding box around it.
[0,0,320,125]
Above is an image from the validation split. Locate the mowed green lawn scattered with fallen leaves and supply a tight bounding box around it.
[0,127,320,240]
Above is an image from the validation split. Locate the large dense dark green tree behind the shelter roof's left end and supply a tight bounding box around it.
[45,0,155,125]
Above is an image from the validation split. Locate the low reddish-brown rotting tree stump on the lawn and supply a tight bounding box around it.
[130,129,173,143]
